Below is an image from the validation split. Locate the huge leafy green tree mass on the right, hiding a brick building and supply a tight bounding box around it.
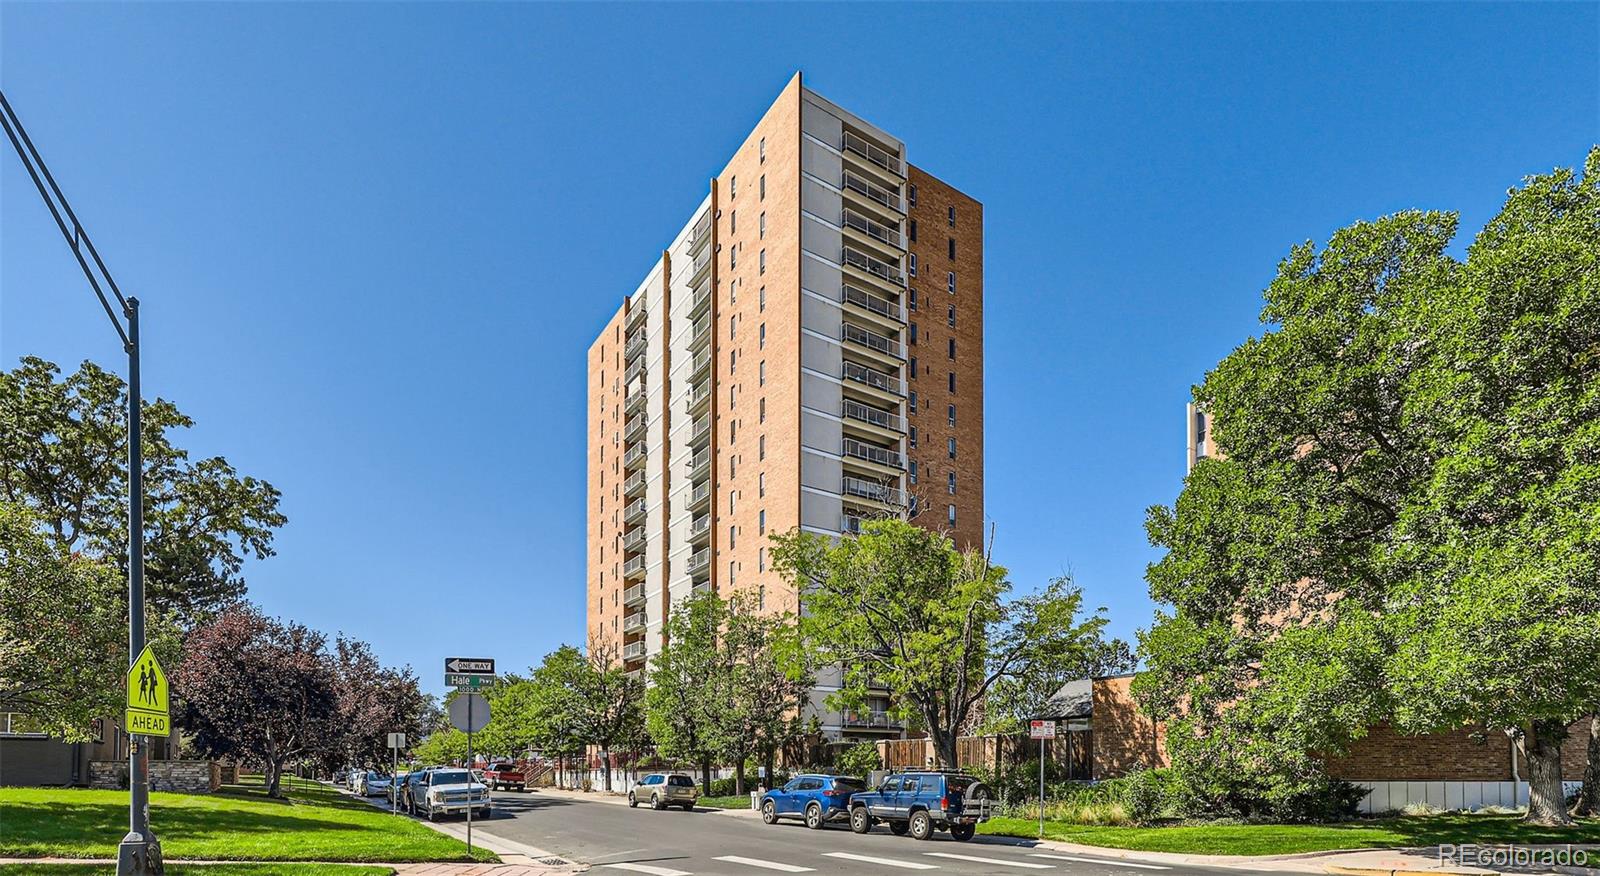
[1136,150,1600,823]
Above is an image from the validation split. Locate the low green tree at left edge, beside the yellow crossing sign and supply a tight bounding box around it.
[0,500,128,742]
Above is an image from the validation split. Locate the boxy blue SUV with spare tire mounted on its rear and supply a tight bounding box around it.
[850,770,992,842]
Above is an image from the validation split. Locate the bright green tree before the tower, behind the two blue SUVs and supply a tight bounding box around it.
[773,520,1106,769]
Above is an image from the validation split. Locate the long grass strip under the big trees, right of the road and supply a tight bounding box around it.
[978,815,1600,855]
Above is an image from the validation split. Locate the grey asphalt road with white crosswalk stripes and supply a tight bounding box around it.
[474,791,1237,876]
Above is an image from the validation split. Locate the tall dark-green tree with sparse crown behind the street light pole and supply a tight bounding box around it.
[0,356,285,625]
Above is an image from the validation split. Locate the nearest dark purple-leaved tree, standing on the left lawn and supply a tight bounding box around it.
[173,604,342,796]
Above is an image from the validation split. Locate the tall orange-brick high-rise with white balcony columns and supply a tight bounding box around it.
[587,74,984,739]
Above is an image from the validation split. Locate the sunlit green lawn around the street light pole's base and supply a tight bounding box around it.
[0,782,498,873]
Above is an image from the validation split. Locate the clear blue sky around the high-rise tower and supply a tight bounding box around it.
[0,3,1600,691]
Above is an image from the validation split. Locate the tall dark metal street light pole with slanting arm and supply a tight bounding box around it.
[0,91,165,876]
